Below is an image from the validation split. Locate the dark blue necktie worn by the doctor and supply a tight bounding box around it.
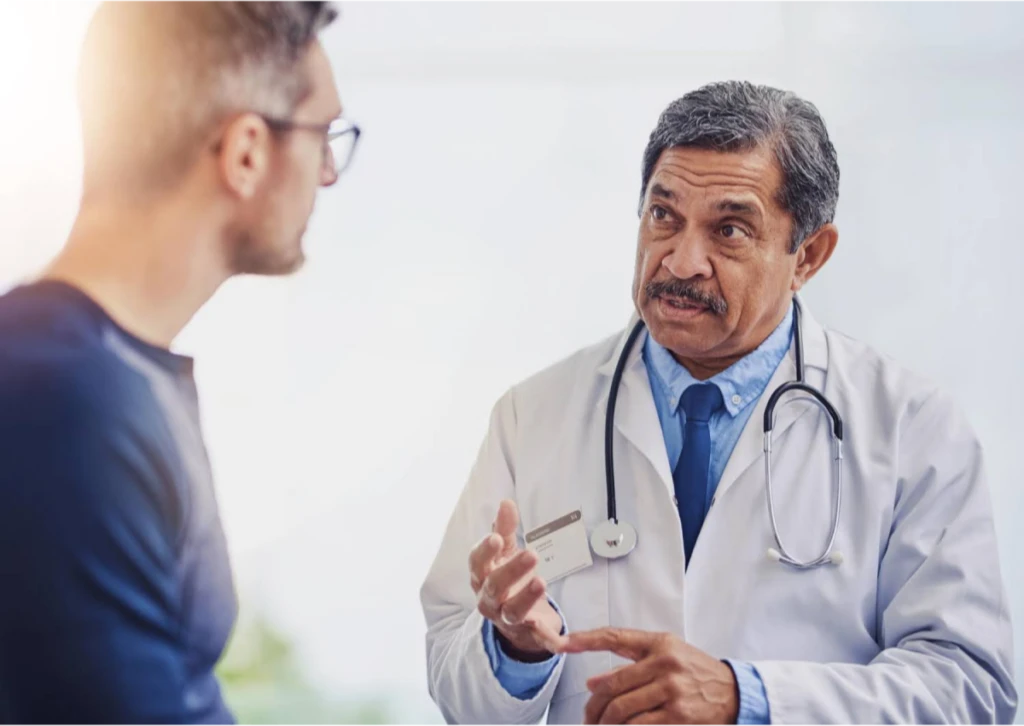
[672,383,723,565]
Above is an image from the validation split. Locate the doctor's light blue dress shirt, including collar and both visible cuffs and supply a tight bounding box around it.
[483,307,793,726]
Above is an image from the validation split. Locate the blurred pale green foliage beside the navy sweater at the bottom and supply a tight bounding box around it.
[217,615,397,726]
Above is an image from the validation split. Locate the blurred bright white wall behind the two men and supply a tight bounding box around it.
[0,0,1024,723]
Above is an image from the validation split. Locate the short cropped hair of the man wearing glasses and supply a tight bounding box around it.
[79,0,337,195]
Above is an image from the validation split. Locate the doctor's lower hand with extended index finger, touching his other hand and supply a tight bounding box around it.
[562,628,739,726]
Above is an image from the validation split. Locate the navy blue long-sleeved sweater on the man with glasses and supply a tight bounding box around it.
[0,282,237,726]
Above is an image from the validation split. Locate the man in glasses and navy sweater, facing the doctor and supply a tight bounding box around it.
[0,0,357,726]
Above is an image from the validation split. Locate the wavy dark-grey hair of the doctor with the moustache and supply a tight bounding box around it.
[640,81,839,252]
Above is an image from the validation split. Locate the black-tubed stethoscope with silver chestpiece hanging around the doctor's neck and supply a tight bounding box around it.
[590,299,843,569]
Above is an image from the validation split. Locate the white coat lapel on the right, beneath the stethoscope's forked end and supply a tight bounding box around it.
[712,298,828,503]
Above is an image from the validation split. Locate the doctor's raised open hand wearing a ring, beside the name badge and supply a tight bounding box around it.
[469,500,565,663]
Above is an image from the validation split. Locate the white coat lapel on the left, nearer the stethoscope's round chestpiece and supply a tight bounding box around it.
[597,315,673,494]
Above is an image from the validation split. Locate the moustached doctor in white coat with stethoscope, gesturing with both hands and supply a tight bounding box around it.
[422,82,1017,726]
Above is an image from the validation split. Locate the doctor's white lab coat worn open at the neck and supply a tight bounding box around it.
[422,308,1017,726]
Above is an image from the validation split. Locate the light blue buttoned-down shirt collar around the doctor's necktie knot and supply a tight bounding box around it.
[643,306,793,417]
